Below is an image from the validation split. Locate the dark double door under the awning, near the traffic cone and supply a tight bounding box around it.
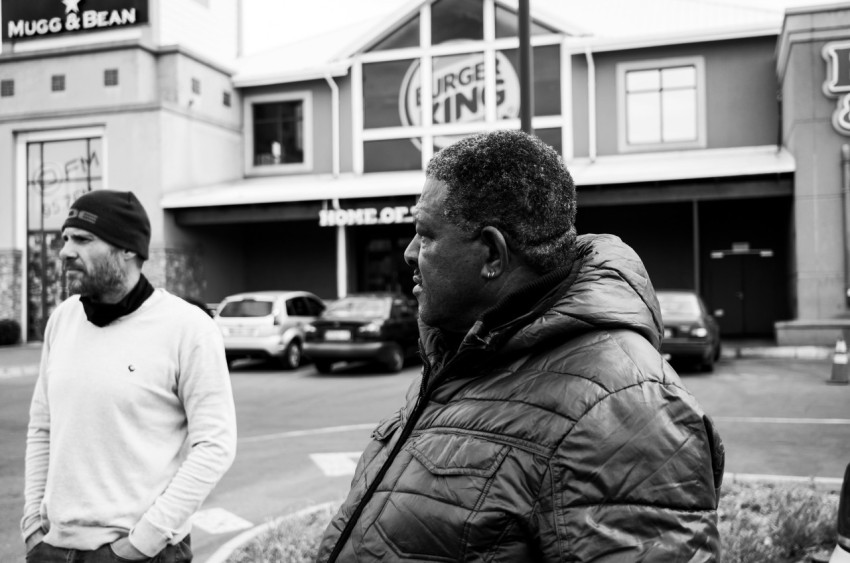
[706,251,781,336]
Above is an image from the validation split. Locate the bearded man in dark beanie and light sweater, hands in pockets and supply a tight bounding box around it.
[21,190,236,562]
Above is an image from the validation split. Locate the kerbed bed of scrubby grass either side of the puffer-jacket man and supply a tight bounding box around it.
[227,483,838,563]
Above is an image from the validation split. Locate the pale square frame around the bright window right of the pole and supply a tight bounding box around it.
[616,56,707,153]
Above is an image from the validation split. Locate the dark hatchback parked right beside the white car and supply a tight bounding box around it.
[304,293,419,373]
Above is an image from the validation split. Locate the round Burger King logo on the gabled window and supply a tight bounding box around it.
[398,51,520,150]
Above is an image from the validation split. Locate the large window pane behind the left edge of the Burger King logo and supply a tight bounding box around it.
[363,59,422,129]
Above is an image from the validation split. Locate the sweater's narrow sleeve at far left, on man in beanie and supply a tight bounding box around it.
[21,340,52,541]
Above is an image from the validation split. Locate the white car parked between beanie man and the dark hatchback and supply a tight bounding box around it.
[215,291,325,369]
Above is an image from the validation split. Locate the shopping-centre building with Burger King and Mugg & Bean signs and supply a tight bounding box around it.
[0,0,850,339]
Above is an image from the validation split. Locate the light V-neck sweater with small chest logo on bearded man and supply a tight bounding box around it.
[21,289,236,557]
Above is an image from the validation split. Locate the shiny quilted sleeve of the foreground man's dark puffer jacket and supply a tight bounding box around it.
[532,382,722,563]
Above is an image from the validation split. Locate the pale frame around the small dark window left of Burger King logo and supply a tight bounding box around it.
[242,90,314,176]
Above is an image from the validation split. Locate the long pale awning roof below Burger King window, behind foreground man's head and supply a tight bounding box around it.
[161,145,795,209]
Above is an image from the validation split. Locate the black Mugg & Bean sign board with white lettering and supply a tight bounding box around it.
[2,0,148,41]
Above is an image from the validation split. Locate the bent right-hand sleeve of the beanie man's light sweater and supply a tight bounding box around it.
[130,319,236,557]
